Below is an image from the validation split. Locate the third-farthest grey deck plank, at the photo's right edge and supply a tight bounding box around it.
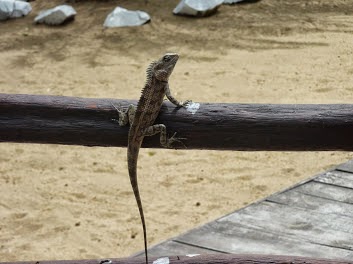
[295,181,353,204]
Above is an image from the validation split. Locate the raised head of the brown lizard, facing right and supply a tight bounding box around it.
[147,53,179,82]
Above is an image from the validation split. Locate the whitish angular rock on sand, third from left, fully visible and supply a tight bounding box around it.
[103,6,151,27]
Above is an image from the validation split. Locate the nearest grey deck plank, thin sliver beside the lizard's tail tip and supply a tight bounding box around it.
[133,240,219,257]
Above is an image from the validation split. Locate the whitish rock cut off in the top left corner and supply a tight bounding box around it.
[0,0,32,20]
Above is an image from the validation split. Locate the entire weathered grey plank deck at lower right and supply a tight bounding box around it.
[138,160,353,260]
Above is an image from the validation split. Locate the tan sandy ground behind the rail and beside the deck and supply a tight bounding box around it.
[0,0,353,261]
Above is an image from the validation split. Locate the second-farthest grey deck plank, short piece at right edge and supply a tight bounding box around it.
[314,170,353,189]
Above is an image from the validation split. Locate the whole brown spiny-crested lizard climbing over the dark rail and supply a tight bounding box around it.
[113,53,191,264]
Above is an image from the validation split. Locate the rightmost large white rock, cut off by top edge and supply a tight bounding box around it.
[173,0,224,16]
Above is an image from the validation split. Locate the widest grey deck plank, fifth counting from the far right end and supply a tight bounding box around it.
[218,201,353,249]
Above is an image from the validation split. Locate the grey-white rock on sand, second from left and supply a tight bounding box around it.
[34,5,77,25]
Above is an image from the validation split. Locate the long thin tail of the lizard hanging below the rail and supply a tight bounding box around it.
[127,146,148,264]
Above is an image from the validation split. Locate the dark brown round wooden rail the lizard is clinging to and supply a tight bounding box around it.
[0,94,353,151]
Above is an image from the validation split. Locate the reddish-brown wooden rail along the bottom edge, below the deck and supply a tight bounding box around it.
[0,254,353,264]
